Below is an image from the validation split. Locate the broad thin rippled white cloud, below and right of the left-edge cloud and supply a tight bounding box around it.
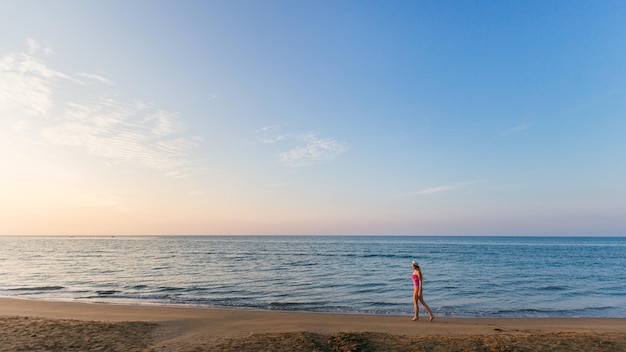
[42,99,200,177]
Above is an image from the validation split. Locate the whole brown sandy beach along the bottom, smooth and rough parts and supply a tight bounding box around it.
[0,298,626,351]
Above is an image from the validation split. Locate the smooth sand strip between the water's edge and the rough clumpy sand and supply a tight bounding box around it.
[0,298,626,351]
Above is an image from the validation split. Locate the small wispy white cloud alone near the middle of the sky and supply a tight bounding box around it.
[256,127,349,167]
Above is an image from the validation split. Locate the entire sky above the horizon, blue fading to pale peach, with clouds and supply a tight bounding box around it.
[0,0,626,236]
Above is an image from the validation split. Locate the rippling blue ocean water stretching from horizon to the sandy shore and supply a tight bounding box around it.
[0,236,626,318]
